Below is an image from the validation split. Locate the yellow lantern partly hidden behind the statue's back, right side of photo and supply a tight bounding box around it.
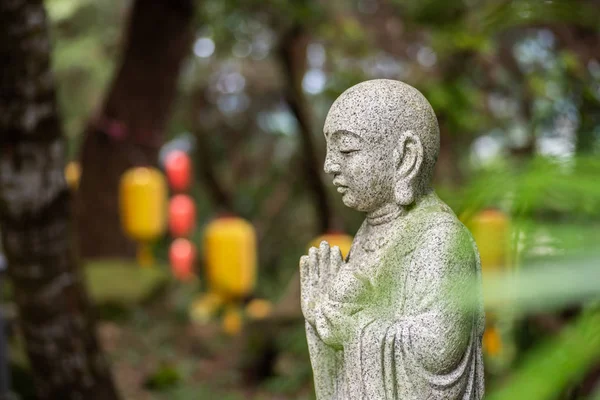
[467,209,509,275]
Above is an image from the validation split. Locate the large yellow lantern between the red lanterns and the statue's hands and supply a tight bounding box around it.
[204,217,256,299]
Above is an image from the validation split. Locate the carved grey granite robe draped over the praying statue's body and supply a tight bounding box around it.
[306,193,484,400]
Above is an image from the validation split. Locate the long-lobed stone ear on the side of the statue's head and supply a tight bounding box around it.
[393,131,423,205]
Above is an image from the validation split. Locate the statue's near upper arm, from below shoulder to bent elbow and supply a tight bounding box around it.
[399,222,479,374]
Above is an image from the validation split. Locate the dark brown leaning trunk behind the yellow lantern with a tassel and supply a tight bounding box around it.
[78,0,194,258]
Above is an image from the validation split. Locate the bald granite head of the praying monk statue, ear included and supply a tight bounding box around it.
[323,79,440,212]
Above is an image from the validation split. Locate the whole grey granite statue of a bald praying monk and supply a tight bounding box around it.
[300,79,484,400]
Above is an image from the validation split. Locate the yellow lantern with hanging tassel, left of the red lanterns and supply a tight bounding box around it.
[119,167,167,265]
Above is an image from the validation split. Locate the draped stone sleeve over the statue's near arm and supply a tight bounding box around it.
[350,221,480,399]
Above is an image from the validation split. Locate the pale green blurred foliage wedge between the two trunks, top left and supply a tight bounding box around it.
[45,0,123,158]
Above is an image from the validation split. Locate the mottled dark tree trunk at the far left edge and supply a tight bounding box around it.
[0,0,118,400]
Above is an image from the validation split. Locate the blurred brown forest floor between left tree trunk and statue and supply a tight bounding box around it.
[99,290,311,400]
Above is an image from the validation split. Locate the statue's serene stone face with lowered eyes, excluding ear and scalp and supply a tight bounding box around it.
[324,130,394,212]
